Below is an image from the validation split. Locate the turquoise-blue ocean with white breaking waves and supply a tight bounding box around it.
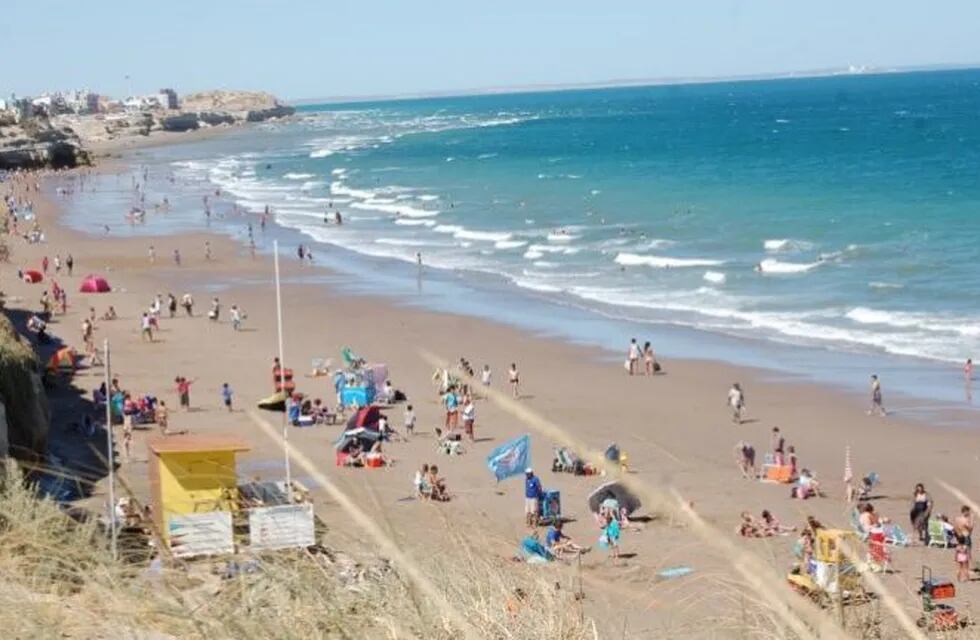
[61,70,980,412]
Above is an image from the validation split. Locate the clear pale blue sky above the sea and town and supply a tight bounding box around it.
[0,0,980,99]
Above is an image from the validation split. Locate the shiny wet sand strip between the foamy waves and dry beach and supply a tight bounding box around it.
[53,136,980,428]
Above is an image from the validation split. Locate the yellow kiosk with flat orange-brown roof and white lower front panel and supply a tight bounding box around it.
[147,436,250,557]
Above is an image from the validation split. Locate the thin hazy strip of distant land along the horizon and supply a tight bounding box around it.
[286,62,980,106]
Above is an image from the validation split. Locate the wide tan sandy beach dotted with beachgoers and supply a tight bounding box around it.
[0,156,980,637]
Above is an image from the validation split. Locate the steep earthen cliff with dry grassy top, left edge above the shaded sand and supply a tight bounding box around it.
[0,313,50,459]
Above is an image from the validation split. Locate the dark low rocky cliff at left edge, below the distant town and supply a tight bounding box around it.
[0,119,90,170]
